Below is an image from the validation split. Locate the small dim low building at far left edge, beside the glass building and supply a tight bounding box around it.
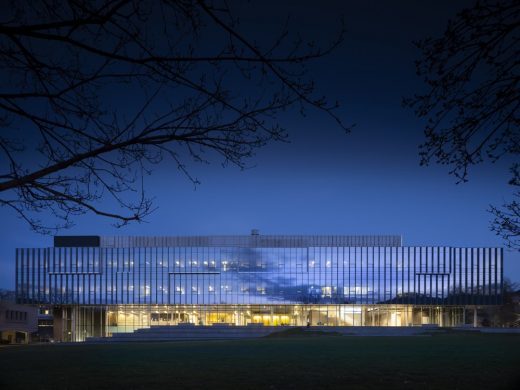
[0,290,38,344]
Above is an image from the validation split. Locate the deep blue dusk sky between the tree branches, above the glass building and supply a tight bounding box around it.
[0,0,520,289]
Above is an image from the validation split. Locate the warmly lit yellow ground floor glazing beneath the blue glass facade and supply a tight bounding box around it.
[53,305,482,341]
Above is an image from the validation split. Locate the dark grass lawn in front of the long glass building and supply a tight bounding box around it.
[0,334,520,390]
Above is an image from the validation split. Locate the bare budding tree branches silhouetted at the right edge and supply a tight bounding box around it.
[404,0,520,248]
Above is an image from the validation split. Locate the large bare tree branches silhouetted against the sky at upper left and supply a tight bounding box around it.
[0,0,347,232]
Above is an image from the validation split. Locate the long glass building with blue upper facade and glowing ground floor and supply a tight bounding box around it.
[16,231,503,341]
